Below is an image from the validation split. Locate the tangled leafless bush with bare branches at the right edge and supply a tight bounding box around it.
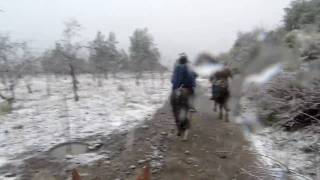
[252,72,320,131]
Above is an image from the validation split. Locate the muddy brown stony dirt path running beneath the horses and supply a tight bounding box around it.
[24,89,271,180]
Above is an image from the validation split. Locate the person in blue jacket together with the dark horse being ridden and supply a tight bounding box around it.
[170,56,196,140]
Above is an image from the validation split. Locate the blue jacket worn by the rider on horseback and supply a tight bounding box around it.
[171,64,196,90]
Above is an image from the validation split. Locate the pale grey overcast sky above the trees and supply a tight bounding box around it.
[0,0,291,64]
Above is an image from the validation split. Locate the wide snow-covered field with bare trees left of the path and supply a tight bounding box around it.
[0,74,170,172]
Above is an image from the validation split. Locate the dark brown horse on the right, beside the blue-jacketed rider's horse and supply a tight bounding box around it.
[210,68,232,121]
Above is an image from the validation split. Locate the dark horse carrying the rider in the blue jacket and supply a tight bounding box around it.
[171,88,192,140]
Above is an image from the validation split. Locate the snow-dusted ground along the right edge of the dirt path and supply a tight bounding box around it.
[237,97,319,180]
